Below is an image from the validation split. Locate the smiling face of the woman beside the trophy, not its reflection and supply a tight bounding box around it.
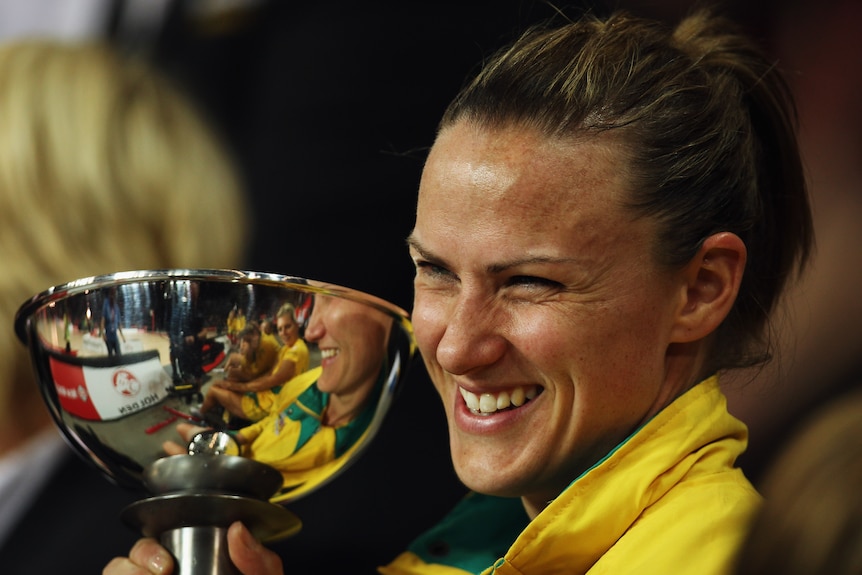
[410,122,684,508]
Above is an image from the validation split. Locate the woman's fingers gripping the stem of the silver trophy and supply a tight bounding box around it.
[102,521,283,575]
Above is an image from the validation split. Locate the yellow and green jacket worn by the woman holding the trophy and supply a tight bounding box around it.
[380,377,760,575]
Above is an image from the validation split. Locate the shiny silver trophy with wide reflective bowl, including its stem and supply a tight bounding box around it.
[15,269,415,575]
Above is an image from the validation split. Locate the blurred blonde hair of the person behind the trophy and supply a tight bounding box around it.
[0,39,247,418]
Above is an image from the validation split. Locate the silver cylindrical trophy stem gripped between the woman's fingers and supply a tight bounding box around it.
[160,527,240,575]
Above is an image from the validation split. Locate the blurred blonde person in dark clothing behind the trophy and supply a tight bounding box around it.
[0,40,247,575]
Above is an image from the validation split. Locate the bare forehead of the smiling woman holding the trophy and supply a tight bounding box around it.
[417,122,625,227]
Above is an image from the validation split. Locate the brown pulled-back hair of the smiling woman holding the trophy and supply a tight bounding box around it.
[439,11,813,369]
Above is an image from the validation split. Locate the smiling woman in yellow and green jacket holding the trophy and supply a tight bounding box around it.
[106,5,812,575]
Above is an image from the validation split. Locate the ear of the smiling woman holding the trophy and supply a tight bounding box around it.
[672,232,747,343]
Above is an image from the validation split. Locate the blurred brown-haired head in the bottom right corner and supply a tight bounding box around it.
[734,391,862,575]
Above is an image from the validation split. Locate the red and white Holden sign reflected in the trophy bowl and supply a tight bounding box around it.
[50,355,170,421]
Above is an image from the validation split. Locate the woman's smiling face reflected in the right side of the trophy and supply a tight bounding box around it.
[305,296,392,394]
